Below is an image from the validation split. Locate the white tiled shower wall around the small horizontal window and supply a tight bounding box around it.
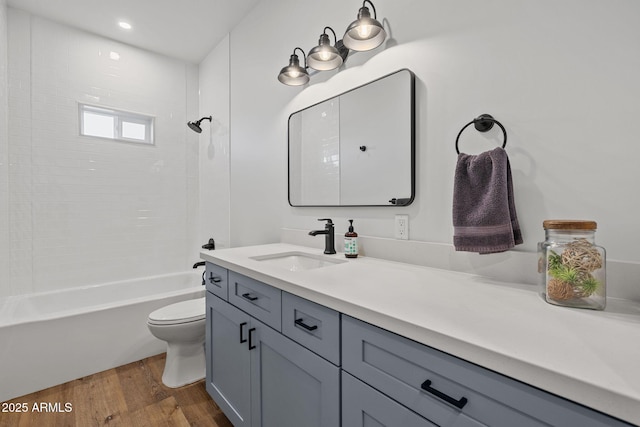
[0,8,199,296]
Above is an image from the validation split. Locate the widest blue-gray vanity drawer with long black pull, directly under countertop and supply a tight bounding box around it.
[342,315,627,427]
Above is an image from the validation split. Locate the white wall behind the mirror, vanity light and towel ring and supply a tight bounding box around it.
[230,0,640,262]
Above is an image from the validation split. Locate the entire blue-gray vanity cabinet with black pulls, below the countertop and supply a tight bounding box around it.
[205,264,630,427]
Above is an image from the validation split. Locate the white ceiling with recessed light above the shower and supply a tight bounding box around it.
[7,0,259,64]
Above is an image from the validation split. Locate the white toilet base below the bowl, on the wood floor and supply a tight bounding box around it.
[162,342,205,388]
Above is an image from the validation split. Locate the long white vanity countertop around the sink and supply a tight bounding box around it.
[200,243,640,424]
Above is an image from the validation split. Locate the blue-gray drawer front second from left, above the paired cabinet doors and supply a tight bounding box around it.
[229,271,282,331]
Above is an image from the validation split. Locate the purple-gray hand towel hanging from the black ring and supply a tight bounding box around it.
[453,147,522,254]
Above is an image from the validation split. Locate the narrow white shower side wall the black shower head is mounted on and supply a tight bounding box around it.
[200,35,230,252]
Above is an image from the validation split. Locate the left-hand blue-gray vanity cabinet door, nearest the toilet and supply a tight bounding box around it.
[205,292,252,427]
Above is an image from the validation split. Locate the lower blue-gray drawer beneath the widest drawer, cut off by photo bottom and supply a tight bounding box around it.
[342,372,437,427]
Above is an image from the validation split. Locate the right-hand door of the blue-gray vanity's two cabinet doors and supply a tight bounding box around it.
[251,321,340,427]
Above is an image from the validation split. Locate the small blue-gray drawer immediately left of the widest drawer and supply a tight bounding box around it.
[282,292,340,366]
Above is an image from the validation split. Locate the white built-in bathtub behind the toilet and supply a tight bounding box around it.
[0,267,205,401]
